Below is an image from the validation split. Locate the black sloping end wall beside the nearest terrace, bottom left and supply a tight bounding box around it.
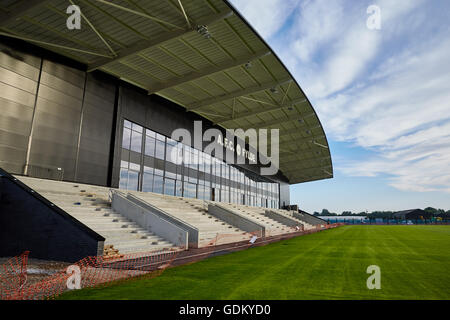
[0,176,104,262]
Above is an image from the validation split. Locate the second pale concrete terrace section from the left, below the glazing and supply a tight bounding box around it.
[129,191,251,247]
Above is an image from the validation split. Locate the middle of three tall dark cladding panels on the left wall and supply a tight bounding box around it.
[29,60,85,181]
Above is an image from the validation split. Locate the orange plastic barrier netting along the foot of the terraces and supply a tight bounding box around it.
[0,223,343,300]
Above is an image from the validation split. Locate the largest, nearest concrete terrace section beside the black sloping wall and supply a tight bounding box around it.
[16,176,178,254]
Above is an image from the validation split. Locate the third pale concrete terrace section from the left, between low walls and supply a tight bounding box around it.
[220,203,296,237]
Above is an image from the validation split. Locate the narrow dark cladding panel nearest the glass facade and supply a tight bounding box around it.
[76,74,116,186]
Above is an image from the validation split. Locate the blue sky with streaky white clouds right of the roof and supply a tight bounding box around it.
[231,0,450,213]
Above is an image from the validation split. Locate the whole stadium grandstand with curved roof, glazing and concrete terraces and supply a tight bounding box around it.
[0,0,333,261]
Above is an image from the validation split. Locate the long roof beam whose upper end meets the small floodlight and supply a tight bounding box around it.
[88,10,233,72]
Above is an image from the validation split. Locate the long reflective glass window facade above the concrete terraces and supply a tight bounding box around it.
[119,120,279,208]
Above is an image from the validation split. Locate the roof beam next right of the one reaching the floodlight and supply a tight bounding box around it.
[148,50,270,94]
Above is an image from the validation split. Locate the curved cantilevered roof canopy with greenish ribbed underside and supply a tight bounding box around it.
[0,0,333,184]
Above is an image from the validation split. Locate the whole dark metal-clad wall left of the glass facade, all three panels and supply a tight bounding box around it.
[0,48,116,186]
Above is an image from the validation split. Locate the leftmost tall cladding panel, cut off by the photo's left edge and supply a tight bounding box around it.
[0,47,41,174]
